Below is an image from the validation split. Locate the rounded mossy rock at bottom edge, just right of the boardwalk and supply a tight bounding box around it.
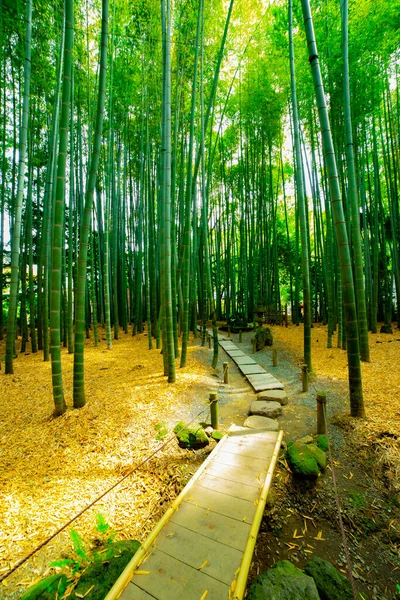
[247,560,320,600]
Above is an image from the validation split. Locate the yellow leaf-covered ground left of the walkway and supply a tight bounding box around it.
[0,333,219,598]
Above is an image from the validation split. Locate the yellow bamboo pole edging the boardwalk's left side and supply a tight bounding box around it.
[104,435,230,600]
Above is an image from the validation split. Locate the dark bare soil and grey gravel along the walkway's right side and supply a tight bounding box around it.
[216,334,400,600]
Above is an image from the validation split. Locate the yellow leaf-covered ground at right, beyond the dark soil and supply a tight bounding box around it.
[273,323,400,492]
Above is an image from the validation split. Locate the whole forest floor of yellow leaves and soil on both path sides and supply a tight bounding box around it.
[0,325,400,600]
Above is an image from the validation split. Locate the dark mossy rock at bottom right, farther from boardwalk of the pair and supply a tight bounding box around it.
[304,556,353,600]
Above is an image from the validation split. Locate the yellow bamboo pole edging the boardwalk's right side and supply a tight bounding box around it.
[231,429,283,600]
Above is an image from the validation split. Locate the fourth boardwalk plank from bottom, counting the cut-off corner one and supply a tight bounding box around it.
[171,502,250,550]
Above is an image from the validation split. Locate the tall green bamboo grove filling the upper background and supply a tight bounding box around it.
[0,0,400,416]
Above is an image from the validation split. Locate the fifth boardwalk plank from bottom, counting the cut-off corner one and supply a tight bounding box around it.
[186,481,255,522]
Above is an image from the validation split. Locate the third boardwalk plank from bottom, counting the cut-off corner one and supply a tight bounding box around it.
[156,523,242,585]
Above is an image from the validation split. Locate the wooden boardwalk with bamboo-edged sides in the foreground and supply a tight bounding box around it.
[105,426,282,600]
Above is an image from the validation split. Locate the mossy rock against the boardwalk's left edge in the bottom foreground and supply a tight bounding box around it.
[70,540,140,600]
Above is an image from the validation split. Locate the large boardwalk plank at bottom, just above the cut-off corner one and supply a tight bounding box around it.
[133,549,229,600]
